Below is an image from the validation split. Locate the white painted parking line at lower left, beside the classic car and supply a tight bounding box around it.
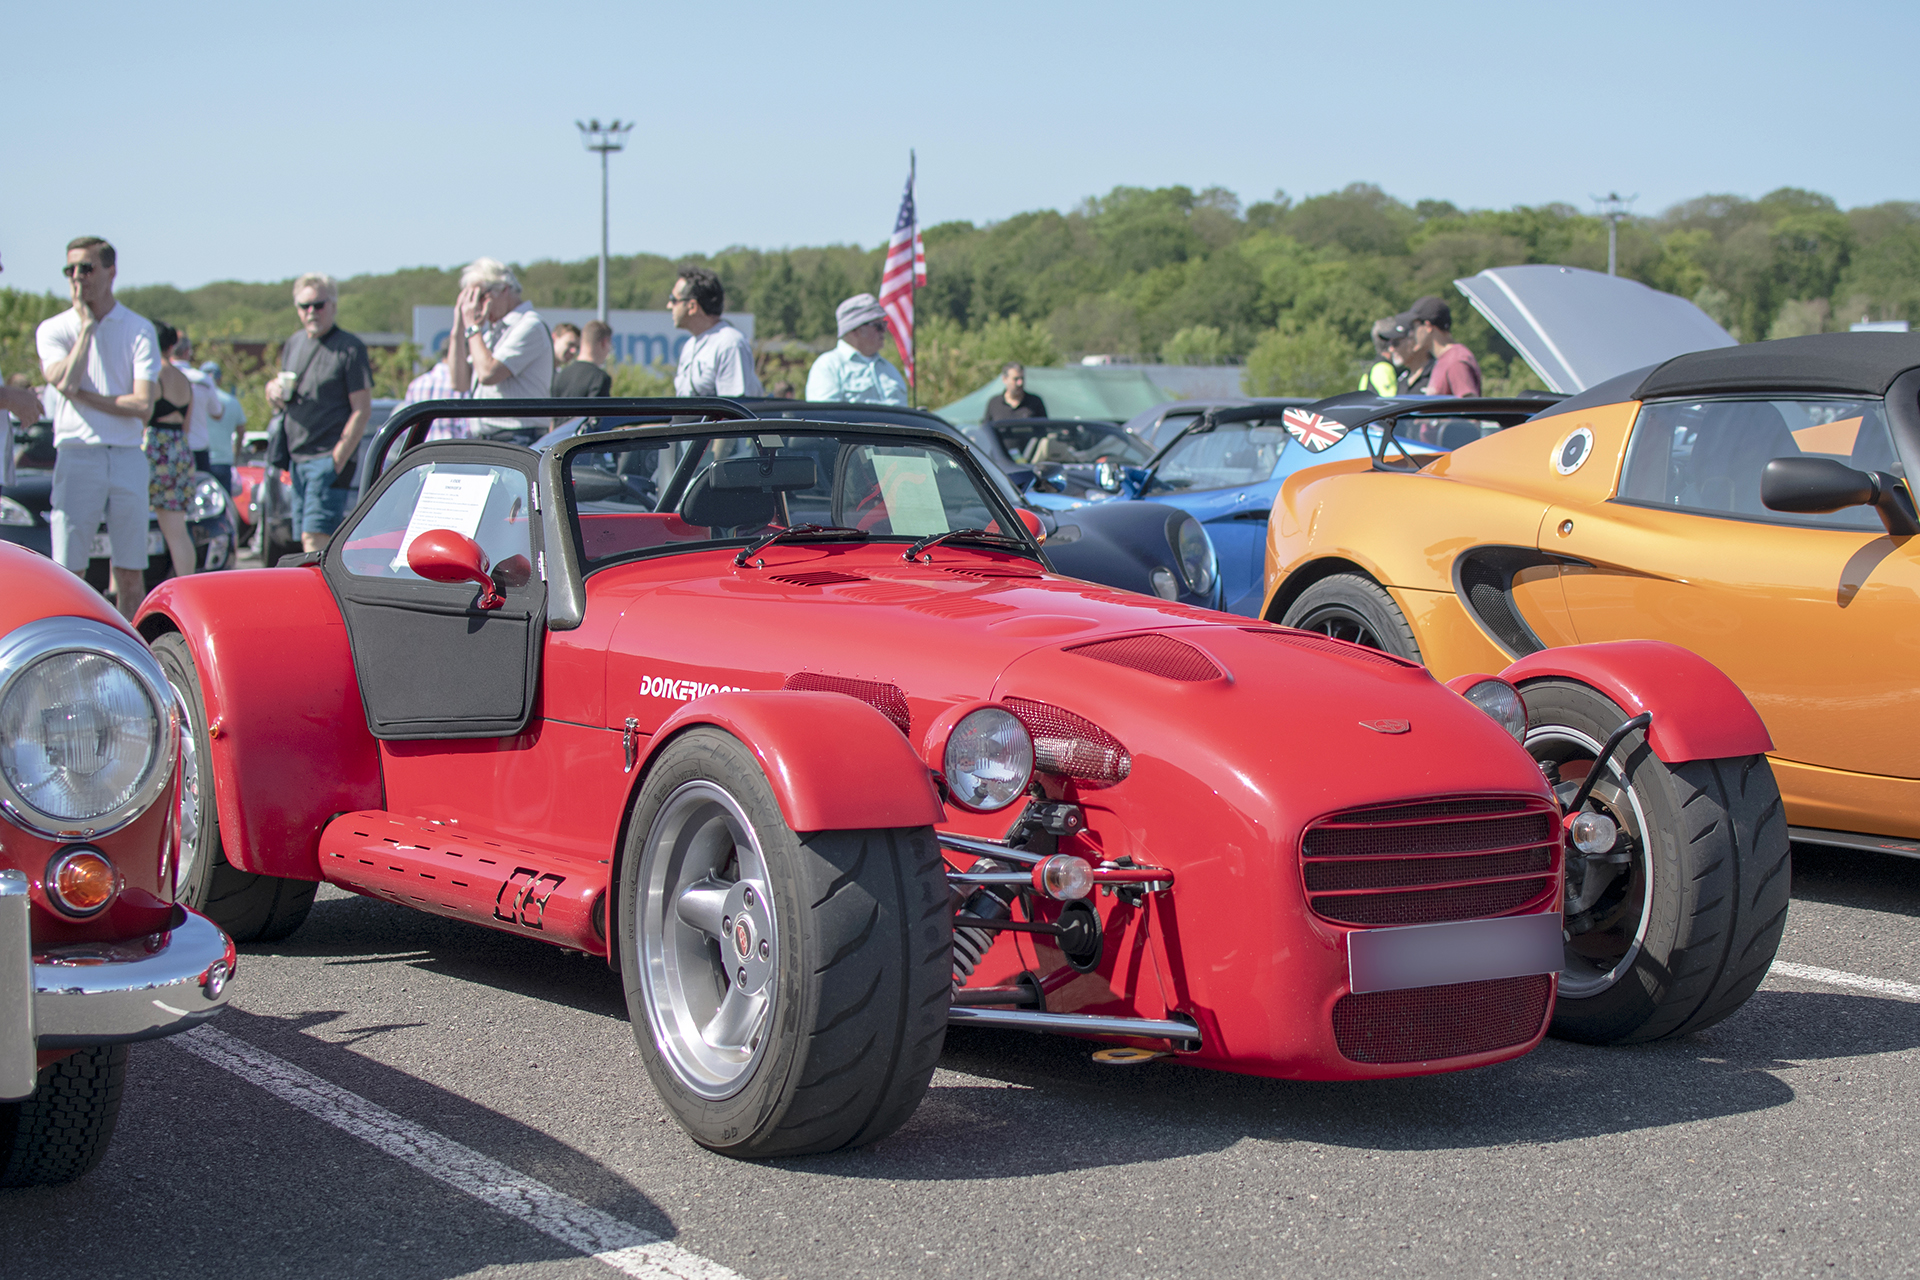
[173,1027,741,1280]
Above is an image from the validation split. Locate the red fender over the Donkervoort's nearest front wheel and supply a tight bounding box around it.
[647,691,947,831]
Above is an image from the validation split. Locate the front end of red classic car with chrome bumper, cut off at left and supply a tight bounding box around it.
[0,547,234,1186]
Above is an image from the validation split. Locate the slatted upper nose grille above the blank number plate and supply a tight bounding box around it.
[1300,796,1561,927]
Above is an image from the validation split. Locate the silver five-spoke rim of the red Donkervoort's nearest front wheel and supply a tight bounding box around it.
[634,781,780,1100]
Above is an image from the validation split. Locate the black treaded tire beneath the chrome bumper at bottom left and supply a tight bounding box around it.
[0,1044,127,1186]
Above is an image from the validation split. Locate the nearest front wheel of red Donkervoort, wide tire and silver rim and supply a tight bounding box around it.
[618,727,952,1159]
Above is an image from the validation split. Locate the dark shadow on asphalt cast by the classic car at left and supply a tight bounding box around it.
[0,1007,676,1280]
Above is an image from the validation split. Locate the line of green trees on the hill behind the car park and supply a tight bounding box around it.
[0,182,1920,405]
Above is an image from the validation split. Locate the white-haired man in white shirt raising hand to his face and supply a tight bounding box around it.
[447,257,553,441]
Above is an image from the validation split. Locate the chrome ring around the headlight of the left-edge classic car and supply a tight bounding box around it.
[0,616,180,841]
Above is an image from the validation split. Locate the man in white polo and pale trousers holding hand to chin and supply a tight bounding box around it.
[36,236,159,618]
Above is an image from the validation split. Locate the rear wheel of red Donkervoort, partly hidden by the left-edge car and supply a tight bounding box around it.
[154,631,319,942]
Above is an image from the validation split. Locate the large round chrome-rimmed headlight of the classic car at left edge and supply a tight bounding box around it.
[0,618,179,837]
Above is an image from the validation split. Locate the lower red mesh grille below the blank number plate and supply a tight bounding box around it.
[1332,973,1553,1063]
